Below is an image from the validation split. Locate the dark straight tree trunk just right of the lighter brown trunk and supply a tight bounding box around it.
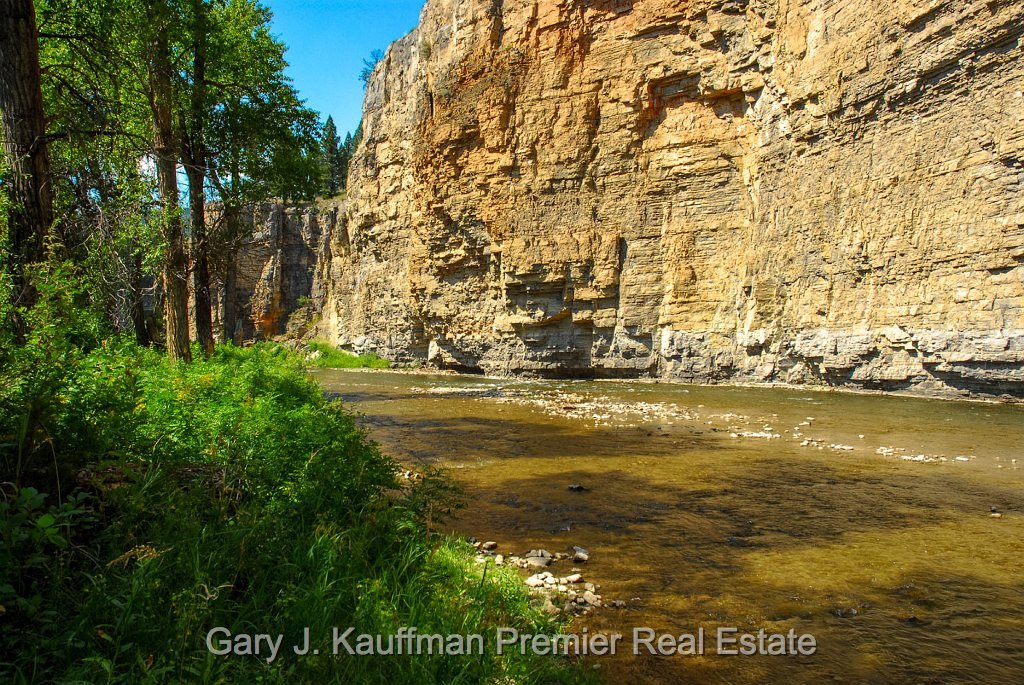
[184,0,213,356]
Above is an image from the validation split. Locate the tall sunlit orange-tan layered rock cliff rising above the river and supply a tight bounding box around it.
[317,0,1024,396]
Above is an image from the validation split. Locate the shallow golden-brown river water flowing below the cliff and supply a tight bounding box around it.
[316,371,1024,685]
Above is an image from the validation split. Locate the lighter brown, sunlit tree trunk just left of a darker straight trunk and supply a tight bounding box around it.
[150,7,191,361]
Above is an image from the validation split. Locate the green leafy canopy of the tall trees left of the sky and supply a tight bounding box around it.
[24,0,322,340]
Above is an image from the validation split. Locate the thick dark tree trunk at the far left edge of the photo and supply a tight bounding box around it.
[0,0,53,304]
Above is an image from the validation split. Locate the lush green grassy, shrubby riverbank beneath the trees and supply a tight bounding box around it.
[0,272,582,683]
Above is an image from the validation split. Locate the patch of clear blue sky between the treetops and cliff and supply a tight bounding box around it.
[263,0,424,138]
